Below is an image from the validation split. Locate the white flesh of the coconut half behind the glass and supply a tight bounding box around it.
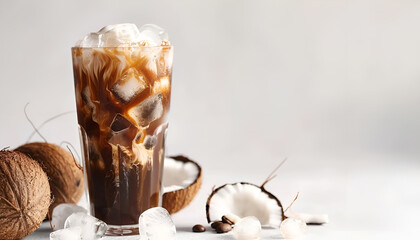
[162,158,200,193]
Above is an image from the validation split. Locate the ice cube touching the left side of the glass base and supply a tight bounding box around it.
[64,212,108,240]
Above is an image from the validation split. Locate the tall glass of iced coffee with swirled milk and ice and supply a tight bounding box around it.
[72,24,172,234]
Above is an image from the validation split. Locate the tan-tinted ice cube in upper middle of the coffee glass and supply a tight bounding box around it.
[111,68,146,103]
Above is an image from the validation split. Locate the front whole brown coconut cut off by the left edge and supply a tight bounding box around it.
[0,151,50,239]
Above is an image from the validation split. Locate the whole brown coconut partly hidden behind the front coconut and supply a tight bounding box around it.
[16,142,84,215]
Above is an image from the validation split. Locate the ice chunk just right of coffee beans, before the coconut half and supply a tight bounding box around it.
[233,216,261,240]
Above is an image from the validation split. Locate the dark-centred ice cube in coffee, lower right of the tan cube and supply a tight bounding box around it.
[128,94,163,127]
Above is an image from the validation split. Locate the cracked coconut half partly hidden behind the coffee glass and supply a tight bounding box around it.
[162,155,201,214]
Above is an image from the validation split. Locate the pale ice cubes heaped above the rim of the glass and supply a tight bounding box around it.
[76,23,169,48]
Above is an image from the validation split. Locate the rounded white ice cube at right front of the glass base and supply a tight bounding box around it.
[139,207,176,240]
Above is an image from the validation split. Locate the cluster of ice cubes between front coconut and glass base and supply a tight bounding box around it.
[50,203,108,240]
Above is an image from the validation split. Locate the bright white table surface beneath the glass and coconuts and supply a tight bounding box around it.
[25,154,420,240]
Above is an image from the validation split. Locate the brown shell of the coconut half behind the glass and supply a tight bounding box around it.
[162,155,202,214]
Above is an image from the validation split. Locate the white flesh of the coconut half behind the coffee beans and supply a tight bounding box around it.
[208,183,282,227]
